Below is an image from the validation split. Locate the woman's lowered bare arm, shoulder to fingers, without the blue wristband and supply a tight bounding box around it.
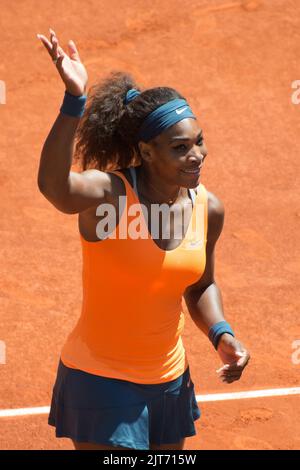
[183,192,250,383]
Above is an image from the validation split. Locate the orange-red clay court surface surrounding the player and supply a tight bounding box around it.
[0,0,300,449]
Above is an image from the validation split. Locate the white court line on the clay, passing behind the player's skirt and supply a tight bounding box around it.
[0,387,300,418]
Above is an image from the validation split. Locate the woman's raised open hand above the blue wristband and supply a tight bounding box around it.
[37,29,88,96]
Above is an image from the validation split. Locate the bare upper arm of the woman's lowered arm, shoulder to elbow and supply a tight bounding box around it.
[184,192,225,296]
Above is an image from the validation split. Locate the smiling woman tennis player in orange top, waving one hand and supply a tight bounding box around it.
[38,30,249,450]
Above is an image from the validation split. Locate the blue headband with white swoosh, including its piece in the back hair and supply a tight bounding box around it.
[126,88,197,142]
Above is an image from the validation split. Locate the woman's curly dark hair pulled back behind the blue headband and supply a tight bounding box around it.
[74,71,184,171]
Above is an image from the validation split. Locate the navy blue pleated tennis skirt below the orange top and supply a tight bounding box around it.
[48,360,201,450]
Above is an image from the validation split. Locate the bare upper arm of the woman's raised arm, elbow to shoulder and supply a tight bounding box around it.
[39,169,119,214]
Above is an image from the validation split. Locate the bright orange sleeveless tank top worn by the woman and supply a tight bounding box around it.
[61,171,207,384]
